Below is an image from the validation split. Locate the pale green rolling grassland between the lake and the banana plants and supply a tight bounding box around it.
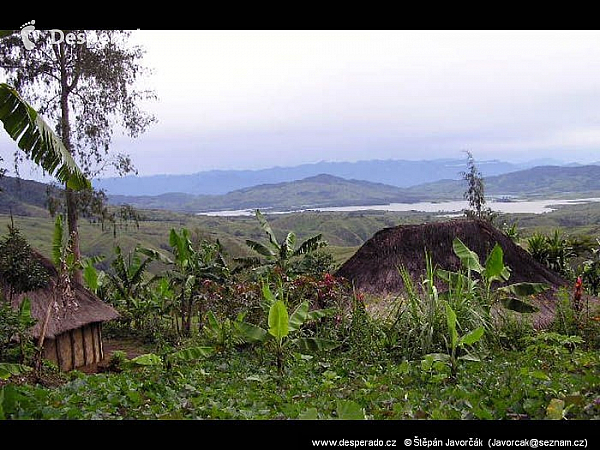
[0,211,432,267]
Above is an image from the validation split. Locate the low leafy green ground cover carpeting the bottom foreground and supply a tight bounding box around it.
[0,339,600,419]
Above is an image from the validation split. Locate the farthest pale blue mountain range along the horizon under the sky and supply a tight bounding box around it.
[94,159,576,196]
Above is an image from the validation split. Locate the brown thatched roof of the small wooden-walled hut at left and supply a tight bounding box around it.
[0,252,119,338]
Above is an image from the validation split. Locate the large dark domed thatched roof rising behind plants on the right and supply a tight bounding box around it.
[337,219,568,326]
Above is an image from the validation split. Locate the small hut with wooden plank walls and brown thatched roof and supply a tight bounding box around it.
[0,252,119,371]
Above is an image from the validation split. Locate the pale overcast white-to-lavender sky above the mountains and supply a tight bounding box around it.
[0,30,600,180]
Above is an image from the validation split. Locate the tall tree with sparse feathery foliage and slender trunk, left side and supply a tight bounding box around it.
[0,30,154,281]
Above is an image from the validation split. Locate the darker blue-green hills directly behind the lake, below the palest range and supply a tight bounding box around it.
[0,165,600,215]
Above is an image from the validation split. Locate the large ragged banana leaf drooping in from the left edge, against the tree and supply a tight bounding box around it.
[0,83,91,190]
